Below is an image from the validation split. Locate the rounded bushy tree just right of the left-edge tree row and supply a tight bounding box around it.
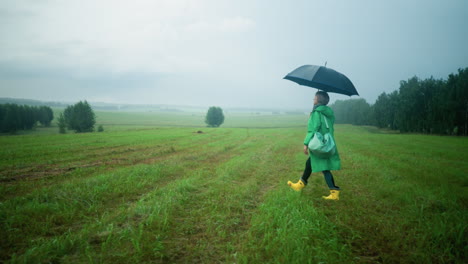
[63,101,96,133]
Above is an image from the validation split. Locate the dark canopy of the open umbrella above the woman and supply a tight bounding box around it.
[283,65,359,96]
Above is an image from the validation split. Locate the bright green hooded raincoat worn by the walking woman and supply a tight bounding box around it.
[304,105,341,172]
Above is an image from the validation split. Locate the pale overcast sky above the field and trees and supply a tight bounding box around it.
[0,0,468,109]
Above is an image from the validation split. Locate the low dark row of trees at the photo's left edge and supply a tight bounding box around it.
[0,104,54,133]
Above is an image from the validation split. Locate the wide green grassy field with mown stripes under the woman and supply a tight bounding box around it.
[0,112,468,263]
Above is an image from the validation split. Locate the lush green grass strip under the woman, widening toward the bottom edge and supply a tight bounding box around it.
[234,137,353,263]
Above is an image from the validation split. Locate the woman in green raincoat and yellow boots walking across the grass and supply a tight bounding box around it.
[288,91,341,200]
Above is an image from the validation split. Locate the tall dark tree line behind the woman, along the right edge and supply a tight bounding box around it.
[331,68,468,136]
